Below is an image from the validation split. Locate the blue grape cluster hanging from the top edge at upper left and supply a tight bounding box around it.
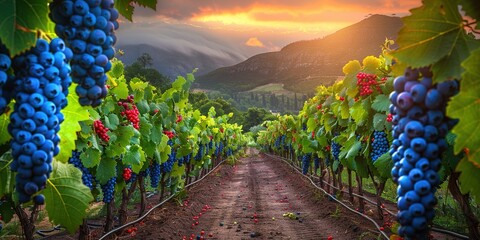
[49,0,119,107]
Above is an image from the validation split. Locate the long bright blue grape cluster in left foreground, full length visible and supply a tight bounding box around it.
[8,38,71,203]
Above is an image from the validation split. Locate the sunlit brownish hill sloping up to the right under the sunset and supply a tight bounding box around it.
[196,15,402,92]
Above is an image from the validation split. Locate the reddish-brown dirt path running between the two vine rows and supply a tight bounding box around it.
[130,152,376,239]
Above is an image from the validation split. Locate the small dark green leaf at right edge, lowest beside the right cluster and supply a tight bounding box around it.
[456,157,480,204]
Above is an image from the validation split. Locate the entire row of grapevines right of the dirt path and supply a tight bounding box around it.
[257,0,480,239]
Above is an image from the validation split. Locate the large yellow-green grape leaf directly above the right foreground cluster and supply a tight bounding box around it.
[392,0,479,82]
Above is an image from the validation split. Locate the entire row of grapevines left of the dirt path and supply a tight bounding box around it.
[0,0,248,239]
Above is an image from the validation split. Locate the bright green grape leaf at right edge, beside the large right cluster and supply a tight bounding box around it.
[447,49,480,164]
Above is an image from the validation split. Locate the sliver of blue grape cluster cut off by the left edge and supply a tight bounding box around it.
[0,42,13,116]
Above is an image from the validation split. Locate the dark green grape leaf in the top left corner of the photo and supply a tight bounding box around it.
[0,0,49,56]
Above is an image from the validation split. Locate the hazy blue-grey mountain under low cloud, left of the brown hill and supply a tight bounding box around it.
[117,44,245,80]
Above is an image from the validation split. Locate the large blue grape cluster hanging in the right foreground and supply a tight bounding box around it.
[390,68,459,239]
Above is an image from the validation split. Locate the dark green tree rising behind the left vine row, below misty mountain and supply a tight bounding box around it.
[124,53,171,92]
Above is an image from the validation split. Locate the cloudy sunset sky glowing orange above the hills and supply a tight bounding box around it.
[118,0,421,58]
